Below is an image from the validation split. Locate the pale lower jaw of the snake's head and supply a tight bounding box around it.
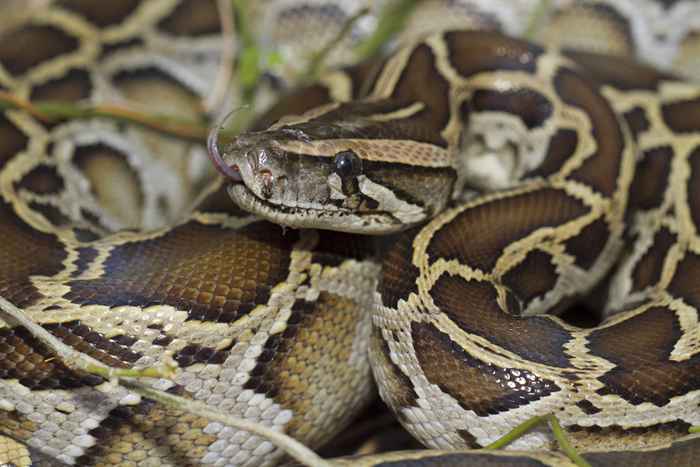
[228,183,403,235]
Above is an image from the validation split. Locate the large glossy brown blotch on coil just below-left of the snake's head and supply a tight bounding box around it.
[66,221,297,323]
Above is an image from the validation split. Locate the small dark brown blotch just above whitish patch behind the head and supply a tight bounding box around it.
[471,88,552,129]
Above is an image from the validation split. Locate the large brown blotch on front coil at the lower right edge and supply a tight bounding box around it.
[588,308,700,407]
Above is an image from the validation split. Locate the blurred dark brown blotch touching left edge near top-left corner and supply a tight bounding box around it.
[0,26,79,76]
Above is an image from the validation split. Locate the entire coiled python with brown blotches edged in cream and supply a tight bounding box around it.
[0,0,700,466]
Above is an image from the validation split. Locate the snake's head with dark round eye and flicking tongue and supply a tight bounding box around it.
[209,108,451,234]
